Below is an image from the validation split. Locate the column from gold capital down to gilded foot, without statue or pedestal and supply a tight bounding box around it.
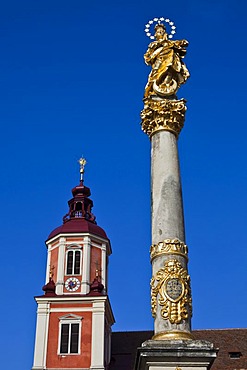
[141,97,192,340]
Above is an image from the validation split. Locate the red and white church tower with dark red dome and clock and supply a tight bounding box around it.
[32,160,114,370]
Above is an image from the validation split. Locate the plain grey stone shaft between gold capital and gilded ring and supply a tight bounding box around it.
[151,131,185,244]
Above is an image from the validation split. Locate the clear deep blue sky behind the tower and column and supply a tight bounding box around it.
[0,0,247,370]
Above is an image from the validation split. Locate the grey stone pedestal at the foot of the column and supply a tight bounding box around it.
[134,340,217,370]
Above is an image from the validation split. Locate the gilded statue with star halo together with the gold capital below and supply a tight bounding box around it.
[141,17,190,137]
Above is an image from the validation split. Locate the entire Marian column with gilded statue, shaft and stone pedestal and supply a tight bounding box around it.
[135,18,216,370]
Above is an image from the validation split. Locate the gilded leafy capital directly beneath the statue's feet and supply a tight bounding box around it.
[141,98,186,137]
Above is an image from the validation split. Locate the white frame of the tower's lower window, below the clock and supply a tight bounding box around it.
[57,314,82,356]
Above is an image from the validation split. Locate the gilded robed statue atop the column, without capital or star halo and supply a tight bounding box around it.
[144,21,190,98]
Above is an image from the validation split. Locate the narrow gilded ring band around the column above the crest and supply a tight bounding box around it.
[150,239,188,261]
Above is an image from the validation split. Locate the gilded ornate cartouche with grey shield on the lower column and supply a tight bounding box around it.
[151,259,192,324]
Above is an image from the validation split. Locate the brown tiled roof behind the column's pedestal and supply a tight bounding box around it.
[110,329,247,370]
